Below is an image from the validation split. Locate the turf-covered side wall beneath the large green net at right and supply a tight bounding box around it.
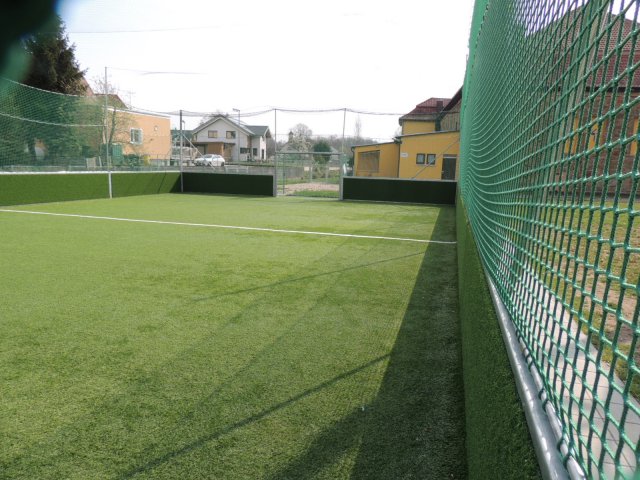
[456,191,541,480]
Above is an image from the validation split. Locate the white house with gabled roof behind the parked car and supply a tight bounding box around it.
[191,115,271,162]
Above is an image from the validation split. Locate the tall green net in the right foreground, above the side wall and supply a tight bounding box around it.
[460,0,640,478]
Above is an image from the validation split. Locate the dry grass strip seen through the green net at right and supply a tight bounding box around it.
[537,197,640,400]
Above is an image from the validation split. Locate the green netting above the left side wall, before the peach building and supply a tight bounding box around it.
[0,78,181,172]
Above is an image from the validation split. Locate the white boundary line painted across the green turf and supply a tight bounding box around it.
[0,208,457,245]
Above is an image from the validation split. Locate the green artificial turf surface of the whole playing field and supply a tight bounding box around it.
[0,194,466,479]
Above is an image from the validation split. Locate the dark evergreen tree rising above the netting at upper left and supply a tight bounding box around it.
[24,15,86,95]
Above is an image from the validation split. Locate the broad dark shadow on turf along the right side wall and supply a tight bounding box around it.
[270,208,467,480]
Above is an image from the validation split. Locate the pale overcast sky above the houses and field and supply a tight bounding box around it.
[59,0,473,138]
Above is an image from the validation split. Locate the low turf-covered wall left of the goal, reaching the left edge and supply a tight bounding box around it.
[0,172,273,205]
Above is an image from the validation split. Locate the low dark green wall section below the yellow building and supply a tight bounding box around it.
[342,177,456,205]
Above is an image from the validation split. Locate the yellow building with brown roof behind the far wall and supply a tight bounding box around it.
[353,89,462,180]
